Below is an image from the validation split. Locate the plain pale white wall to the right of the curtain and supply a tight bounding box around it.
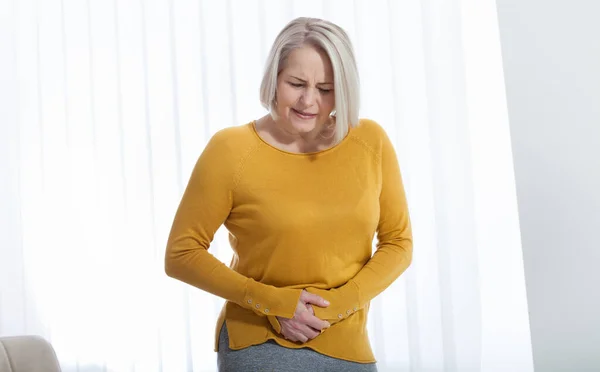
[497,0,600,372]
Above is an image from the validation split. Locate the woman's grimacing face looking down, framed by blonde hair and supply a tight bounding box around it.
[276,45,335,134]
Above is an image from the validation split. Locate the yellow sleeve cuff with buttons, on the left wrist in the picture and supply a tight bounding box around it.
[242,279,302,318]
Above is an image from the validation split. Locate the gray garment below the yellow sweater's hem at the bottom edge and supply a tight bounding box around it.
[217,324,377,372]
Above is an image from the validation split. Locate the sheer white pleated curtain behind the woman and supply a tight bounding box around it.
[0,0,533,372]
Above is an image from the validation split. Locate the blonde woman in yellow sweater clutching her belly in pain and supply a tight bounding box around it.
[165,18,412,372]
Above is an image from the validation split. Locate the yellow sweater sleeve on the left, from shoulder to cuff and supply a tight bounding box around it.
[165,131,301,318]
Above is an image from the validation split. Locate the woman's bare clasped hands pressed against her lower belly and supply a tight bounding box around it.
[277,290,331,343]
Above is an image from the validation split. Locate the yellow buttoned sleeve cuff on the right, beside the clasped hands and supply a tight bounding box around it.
[306,280,358,324]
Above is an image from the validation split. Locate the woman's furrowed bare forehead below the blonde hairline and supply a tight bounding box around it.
[282,46,333,80]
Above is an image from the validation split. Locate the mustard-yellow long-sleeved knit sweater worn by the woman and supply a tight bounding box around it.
[165,119,412,363]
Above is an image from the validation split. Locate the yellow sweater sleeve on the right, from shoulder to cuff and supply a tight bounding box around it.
[306,126,412,324]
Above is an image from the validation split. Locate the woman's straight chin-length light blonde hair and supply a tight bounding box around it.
[260,17,360,143]
